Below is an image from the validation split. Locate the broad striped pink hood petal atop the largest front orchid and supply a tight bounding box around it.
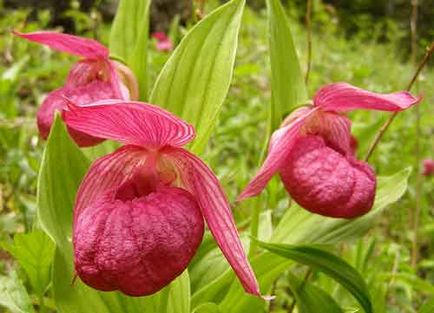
[64,100,195,148]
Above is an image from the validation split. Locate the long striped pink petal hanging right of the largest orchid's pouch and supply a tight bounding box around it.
[162,147,260,296]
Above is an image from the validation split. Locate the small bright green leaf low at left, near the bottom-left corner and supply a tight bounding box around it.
[3,230,54,296]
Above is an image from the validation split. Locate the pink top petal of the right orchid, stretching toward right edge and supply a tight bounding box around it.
[313,83,422,112]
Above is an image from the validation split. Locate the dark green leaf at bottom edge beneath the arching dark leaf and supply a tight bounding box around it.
[287,273,343,313]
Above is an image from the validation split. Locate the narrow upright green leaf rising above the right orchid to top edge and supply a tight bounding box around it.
[267,0,308,132]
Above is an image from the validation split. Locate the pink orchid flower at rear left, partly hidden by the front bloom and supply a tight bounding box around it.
[14,31,138,147]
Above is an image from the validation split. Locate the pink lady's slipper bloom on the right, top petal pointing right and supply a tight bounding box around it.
[238,83,420,218]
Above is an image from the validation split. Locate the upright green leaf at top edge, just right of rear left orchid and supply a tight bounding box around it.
[110,0,151,101]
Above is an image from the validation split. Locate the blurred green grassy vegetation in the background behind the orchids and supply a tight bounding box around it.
[0,1,434,312]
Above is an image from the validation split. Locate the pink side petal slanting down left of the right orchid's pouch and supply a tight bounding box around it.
[237,108,316,201]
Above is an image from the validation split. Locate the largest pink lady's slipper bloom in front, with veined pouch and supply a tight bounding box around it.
[64,100,259,296]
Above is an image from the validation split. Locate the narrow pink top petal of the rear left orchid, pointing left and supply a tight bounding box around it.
[13,31,109,59]
